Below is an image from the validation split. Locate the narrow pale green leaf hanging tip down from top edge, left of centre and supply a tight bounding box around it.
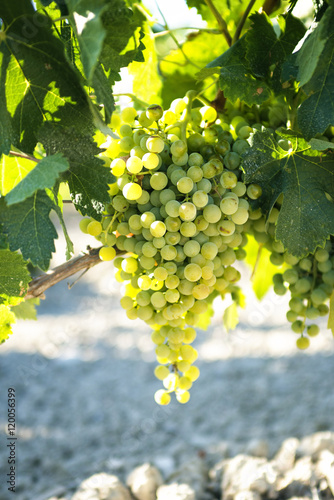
[66,0,109,84]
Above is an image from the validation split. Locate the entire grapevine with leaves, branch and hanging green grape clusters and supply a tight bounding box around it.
[0,0,334,405]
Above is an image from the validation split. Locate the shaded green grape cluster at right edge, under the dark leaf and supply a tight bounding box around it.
[244,193,334,349]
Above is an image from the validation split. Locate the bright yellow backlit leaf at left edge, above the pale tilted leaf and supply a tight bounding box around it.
[0,155,36,196]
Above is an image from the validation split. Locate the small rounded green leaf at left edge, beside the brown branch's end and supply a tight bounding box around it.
[0,250,31,297]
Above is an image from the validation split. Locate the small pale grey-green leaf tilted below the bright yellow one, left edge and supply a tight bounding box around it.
[6,153,69,205]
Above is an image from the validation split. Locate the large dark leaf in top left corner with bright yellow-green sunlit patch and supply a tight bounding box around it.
[0,1,93,153]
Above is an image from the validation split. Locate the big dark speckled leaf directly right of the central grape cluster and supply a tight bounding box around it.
[242,132,334,257]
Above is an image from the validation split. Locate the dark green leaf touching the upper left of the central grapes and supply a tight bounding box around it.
[40,126,115,219]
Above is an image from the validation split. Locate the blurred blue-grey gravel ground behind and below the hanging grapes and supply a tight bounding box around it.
[0,205,334,500]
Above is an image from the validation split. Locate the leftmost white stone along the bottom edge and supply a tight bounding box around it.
[72,472,131,500]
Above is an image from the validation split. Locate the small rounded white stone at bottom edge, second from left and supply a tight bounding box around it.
[126,464,163,500]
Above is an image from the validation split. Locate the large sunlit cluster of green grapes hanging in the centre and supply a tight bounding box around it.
[80,92,261,405]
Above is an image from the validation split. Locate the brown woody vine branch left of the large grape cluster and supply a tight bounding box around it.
[24,247,124,300]
